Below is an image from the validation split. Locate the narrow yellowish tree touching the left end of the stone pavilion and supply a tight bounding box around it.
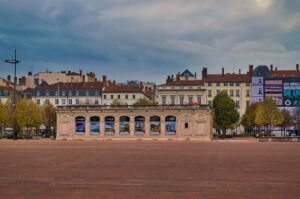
[40,101,56,130]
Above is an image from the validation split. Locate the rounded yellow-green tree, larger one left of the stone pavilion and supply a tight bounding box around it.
[15,99,42,137]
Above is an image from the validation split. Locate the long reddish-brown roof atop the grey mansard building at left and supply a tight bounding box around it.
[35,82,103,90]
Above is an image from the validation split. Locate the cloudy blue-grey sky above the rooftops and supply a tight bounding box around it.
[0,0,300,83]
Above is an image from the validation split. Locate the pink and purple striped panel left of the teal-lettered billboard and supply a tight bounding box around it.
[265,80,283,106]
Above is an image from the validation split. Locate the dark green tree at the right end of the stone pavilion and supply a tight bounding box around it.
[213,91,240,135]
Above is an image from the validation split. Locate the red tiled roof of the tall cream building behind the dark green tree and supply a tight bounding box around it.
[207,73,251,83]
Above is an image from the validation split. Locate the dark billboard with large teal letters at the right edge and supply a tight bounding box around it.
[283,79,300,107]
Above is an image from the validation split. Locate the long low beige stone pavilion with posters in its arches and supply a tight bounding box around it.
[57,106,212,140]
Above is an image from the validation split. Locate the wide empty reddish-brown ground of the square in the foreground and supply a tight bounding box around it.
[0,140,300,199]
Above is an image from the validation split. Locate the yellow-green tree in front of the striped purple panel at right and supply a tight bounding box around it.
[255,97,283,134]
